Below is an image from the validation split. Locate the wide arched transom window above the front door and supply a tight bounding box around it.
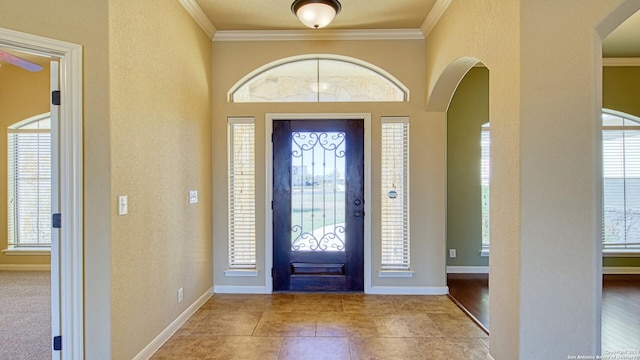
[228,55,409,103]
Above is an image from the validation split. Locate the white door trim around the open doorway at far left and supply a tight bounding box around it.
[0,28,84,359]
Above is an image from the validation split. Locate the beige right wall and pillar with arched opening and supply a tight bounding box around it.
[426,0,640,360]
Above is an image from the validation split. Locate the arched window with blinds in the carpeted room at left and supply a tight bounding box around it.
[7,113,51,249]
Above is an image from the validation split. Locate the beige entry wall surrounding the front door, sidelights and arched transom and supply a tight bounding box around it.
[212,40,445,291]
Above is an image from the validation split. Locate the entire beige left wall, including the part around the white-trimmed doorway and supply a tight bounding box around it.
[0,0,212,359]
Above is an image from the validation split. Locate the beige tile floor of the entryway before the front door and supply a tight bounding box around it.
[152,294,488,360]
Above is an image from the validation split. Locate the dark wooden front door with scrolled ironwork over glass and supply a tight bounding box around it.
[273,120,365,291]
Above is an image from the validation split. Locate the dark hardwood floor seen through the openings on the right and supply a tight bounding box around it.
[447,274,640,354]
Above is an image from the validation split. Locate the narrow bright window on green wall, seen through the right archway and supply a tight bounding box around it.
[480,123,491,256]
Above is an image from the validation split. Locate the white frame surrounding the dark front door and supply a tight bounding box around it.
[264,113,372,294]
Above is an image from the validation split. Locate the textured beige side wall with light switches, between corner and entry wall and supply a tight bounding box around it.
[109,0,213,359]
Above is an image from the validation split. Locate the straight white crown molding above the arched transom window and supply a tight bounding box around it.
[213,29,424,41]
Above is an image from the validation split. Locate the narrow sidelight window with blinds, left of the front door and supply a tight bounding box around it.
[227,118,256,269]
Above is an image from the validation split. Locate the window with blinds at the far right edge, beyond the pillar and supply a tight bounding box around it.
[602,110,640,252]
